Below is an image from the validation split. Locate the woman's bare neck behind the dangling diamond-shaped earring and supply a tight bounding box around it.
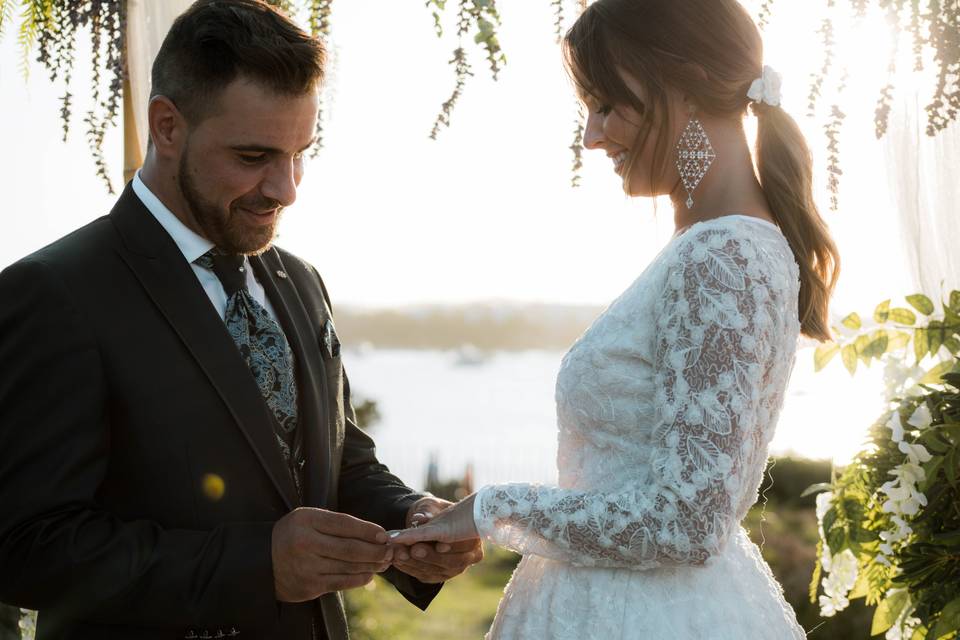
[670,118,773,229]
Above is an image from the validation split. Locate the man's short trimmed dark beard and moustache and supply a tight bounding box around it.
[177,147,283,255]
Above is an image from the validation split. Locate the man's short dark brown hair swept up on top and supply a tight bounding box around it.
[150,0,326,126]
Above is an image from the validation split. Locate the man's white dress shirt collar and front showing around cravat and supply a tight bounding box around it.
[133,171,280,325]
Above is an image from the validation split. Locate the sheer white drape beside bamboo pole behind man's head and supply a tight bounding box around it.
[127,0,193,158]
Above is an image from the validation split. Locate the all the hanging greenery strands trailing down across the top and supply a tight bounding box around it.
[0,0,960,195]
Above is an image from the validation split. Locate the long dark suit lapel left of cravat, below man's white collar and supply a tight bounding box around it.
[110,184,299,509]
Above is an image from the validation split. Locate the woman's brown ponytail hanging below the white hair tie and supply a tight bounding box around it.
[753,104,840,341]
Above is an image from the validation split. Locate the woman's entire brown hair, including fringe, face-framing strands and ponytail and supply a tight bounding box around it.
[563,0,840,340]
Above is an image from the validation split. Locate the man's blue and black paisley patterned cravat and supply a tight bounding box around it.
[194,249,304,498]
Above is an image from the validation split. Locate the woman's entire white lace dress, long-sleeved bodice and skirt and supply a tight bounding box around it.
[474,215,805,640]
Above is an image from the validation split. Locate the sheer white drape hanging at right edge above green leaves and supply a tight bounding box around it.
[885,91,960,301]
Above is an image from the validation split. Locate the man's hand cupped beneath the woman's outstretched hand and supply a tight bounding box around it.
[393,496,483,584]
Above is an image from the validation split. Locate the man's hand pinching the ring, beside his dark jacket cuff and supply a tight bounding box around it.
[271,507,393,602]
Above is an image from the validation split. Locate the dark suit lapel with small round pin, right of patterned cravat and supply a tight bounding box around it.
[250,249,335,507]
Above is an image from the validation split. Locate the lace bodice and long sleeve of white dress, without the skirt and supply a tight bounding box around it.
[475,216,799,569]
